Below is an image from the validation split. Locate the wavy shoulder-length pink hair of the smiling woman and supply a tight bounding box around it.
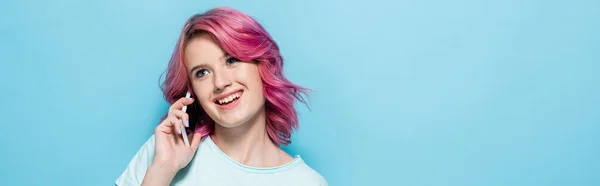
[161,8,308,145]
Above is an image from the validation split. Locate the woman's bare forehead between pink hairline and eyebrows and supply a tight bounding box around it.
[184,34,225,65]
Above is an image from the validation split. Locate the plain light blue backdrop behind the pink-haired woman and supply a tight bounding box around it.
[0,0,600,186]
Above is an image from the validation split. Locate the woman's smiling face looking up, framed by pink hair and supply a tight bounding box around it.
[184,34,265,128]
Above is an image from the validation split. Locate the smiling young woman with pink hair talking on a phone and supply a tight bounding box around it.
[115,8,327,186]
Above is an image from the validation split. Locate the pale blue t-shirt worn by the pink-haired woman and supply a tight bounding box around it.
[115,135,327,186]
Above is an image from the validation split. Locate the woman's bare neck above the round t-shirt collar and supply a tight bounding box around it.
[211,108,291,167]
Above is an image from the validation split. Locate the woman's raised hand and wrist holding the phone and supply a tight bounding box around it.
[142,98,202,185]
